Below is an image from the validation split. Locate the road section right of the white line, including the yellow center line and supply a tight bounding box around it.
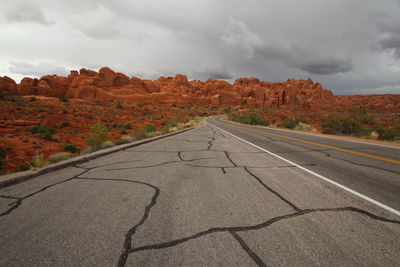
[208,116,400,215]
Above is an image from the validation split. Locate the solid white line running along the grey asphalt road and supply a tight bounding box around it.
[206,120,400,219]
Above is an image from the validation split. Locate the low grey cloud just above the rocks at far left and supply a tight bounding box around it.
[9,61,68,77]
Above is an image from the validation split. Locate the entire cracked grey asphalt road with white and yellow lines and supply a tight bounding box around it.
[0,118,400,266]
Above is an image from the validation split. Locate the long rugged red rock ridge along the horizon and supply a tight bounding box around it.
[0,67,400,112]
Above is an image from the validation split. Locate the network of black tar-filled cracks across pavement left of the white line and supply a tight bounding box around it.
[0,126,400,267]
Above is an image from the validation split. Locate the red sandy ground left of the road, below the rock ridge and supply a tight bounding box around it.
[0,96,217,174]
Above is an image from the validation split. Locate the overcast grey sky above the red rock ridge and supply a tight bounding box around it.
[0,0,400,94]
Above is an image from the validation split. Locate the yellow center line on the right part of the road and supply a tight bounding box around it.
[219,121,400,164]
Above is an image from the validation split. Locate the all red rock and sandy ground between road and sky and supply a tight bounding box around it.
[0,67,400,174]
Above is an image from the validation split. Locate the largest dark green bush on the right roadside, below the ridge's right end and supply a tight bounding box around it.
[321,115,366,136]
